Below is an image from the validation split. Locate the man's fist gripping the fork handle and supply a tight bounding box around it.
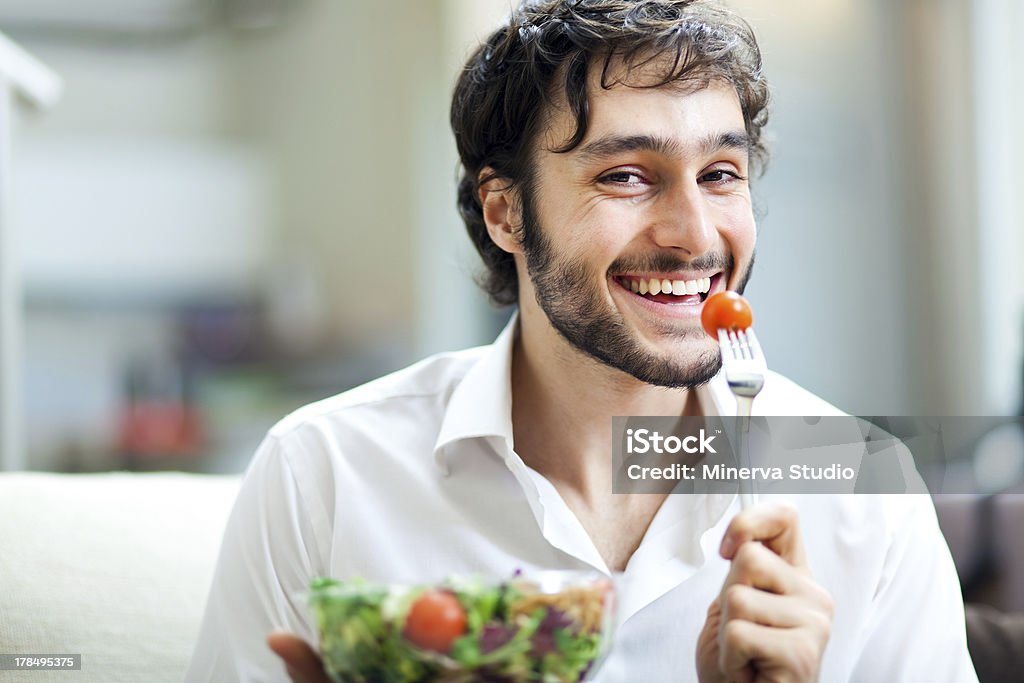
[697,505,833,683]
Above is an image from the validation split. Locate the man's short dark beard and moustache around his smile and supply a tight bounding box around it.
[521,187,754,389]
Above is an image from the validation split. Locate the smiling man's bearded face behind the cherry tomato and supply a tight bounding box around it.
[519,70,756,387]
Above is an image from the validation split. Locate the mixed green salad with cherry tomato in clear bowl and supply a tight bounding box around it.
[309,572,613,683]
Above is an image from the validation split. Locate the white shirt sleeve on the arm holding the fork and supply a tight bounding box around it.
[850,494,978,683]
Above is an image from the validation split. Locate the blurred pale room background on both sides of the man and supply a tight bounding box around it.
[0,0,1024,472]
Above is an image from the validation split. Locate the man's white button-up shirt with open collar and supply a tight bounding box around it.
[186,318,977,683]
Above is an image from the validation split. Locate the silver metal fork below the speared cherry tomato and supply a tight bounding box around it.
[718,328,768,510]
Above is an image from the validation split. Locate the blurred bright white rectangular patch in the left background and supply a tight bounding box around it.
[18,135,276,296]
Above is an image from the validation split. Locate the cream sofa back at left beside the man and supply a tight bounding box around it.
[0,473,240,683]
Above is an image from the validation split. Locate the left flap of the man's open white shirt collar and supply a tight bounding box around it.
[434,312,519,474]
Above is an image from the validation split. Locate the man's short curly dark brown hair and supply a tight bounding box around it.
[451,0,768,305]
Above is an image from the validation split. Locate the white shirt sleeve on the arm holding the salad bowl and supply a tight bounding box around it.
[185,435,323,683]
